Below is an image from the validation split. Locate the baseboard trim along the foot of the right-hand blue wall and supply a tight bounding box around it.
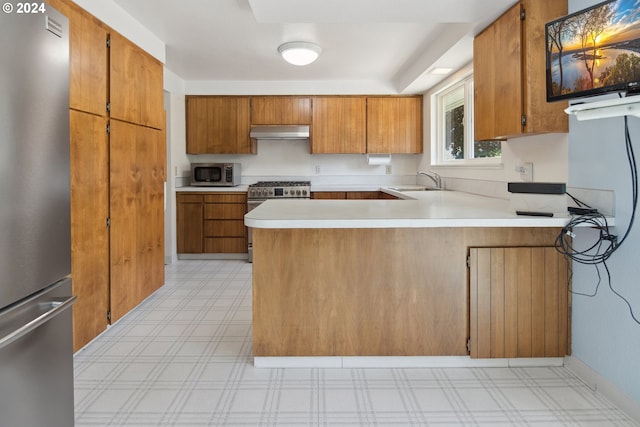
[564,356,640,424]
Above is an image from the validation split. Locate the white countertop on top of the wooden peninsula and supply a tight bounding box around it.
[245,187,570,228]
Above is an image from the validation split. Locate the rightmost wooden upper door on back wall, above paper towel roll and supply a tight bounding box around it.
[367,96,422,154]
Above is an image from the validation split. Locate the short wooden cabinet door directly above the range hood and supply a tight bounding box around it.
[251,96,311,125]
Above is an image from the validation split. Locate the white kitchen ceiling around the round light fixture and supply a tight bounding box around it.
[114,0,516,93]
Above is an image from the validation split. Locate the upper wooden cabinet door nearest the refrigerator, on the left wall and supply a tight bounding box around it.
[49,0,109,116]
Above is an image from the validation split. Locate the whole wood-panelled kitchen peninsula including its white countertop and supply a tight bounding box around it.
[245,189,570,358]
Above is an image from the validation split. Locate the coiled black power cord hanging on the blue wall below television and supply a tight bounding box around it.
[555,112,640,325]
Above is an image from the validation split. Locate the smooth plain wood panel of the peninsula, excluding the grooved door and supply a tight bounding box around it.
[252,228,566,356]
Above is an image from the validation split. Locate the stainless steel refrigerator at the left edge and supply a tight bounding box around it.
[0,2,74,427]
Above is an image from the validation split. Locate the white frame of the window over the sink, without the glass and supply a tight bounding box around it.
[430,70,502,167]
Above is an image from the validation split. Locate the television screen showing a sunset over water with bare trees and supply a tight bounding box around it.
[545,0,640,101]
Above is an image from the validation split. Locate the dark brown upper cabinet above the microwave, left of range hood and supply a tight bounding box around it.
[186,95,256,154]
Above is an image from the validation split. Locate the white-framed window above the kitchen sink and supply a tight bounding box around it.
[431,75,501,165]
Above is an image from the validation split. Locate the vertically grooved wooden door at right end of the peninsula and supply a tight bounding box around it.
[469,247,570,358]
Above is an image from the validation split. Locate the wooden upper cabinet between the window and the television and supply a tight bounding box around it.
[473,0,569,141]
